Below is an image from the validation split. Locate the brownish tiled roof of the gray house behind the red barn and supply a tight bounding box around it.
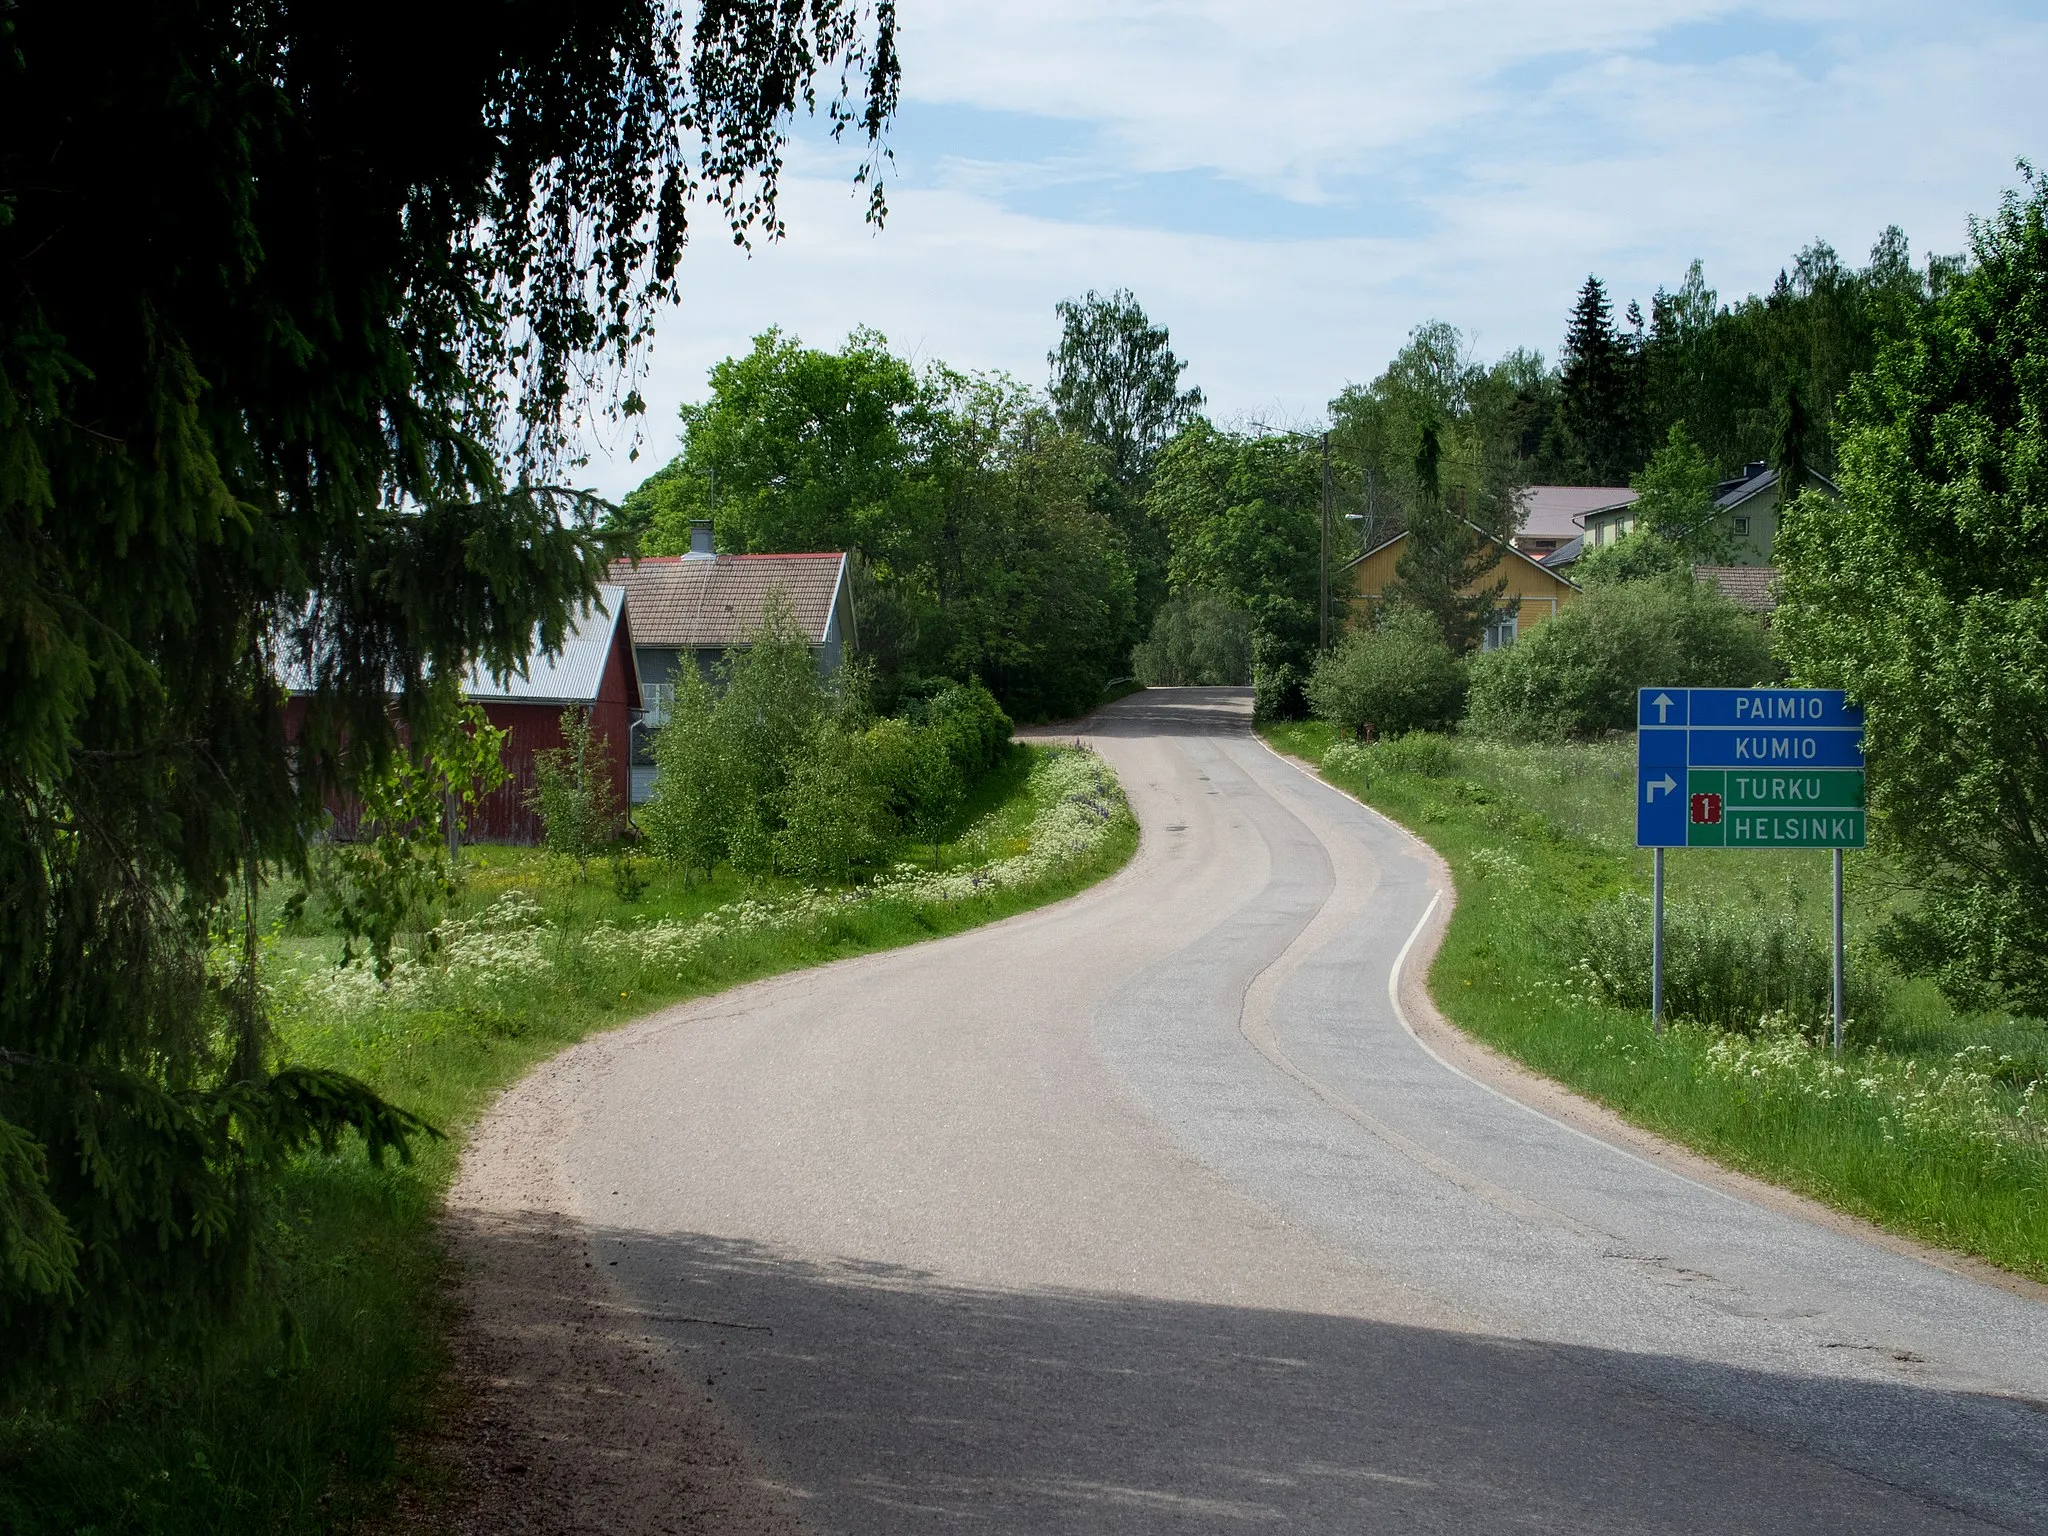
[612,555,846,649]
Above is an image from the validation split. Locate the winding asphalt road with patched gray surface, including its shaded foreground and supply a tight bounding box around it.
[557,690,2048,1532]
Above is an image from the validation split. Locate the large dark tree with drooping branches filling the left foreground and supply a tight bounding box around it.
[0,0,897,1368]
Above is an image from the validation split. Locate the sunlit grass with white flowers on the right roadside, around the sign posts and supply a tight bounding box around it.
[1266,723,2048,1280]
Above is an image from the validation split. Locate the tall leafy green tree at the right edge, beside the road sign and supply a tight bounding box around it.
[1778,166,2048,1014]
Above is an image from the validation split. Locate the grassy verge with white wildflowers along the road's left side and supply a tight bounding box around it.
[0,745,1137,1536]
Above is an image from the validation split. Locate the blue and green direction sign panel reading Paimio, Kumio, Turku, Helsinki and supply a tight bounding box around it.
[1636,688,1868,848]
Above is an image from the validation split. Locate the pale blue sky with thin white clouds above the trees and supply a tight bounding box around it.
[578,0,2048,498]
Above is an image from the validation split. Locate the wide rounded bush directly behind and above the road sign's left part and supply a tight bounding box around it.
[1466,573,1774,741]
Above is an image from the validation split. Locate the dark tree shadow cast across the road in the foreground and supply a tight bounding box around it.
[452,1214,2048,1534]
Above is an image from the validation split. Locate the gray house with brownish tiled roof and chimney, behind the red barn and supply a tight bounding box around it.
[610,522,856,805]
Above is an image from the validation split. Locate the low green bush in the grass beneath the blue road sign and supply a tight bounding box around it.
[1556,891,1886,1032]
